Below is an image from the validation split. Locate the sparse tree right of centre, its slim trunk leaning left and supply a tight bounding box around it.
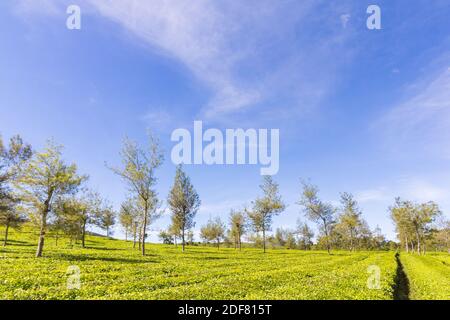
[298,182,335,253]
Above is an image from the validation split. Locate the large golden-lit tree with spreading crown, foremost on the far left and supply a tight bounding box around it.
[15,142,87,257]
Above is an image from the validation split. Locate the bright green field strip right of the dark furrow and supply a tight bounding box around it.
[400,253,450,300]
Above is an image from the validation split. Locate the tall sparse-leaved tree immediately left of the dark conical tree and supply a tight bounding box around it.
[111,135,163,255]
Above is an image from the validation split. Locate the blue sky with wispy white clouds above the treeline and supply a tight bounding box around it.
[0,0,450,239]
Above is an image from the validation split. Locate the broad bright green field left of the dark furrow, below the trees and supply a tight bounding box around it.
[0,228,396,299]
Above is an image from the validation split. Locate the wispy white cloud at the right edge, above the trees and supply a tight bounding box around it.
[377,65,450,159]
